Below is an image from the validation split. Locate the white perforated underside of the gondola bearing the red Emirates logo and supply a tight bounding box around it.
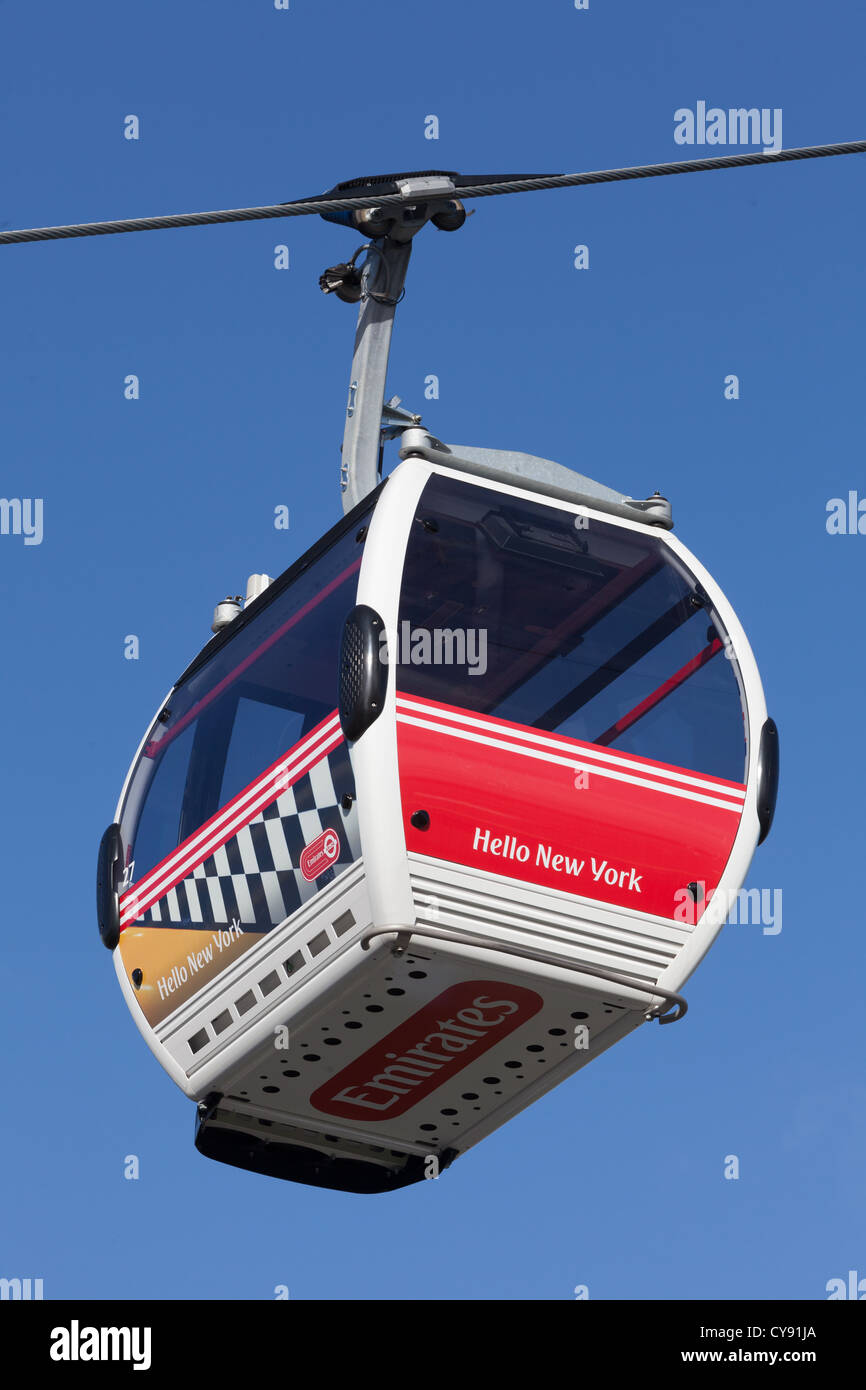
[211,949,642,1166]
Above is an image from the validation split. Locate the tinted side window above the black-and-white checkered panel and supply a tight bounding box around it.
[121,518,363,884]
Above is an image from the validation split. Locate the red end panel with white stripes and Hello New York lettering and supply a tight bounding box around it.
[398,695,745,922]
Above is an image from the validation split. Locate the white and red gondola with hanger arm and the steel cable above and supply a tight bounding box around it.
[10,142,866,1193]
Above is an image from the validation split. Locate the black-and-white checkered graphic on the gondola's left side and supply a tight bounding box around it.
[138,742,361,931]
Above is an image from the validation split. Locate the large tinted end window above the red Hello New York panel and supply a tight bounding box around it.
[400,474,745,783]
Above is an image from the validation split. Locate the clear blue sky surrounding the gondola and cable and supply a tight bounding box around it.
[0,0,866,1300]
